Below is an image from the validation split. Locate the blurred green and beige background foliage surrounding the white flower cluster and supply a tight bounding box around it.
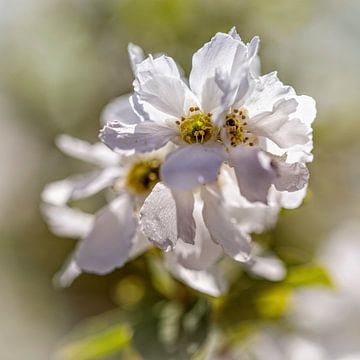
[0,0,360,360]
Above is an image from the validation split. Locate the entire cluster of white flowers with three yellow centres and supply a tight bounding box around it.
[43,29,316,296]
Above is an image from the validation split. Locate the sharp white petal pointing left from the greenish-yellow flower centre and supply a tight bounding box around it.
[99,121,178,153]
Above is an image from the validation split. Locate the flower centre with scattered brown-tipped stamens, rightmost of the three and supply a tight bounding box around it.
[223,108,258,146]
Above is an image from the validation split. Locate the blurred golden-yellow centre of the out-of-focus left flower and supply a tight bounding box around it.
[126,159,161,194]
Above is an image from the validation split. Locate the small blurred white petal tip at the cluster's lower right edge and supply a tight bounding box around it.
[245,255,286,281]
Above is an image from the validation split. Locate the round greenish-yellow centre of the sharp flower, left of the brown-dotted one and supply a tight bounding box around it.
[179,107,215,144]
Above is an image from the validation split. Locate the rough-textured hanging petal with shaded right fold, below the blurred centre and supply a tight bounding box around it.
[140,183,196,251]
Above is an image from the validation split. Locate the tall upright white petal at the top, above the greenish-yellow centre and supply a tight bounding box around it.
[189,33,246,112]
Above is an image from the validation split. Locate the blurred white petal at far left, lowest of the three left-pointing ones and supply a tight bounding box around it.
[41,204,94,238]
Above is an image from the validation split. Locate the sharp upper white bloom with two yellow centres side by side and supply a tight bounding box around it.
[100,29,315,203]
